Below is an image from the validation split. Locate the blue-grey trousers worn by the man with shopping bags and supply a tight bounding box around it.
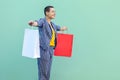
[37,47,54,80]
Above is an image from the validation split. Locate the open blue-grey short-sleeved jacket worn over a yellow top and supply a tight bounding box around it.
[36,18,60,50]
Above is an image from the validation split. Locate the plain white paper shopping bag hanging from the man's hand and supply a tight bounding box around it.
[22,29,40,58]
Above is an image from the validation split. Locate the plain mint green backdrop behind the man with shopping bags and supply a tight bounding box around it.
[0,0,120,80]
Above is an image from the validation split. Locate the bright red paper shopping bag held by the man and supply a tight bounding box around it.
[54,33,73,57]
